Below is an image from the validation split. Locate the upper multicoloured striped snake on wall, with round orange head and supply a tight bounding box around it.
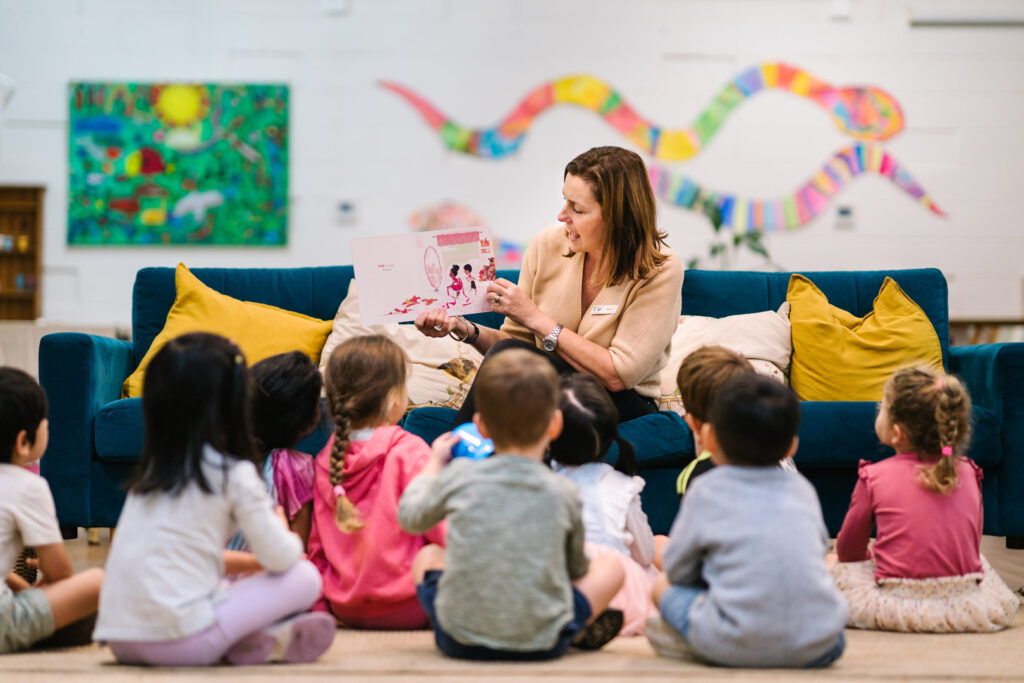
[380,62,903,161]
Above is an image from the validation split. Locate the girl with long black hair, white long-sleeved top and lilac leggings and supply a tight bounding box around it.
[93,333,335,667]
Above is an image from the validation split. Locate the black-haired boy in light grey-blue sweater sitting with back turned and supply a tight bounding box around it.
[646,374,846,667]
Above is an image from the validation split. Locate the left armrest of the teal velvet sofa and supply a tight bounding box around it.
[39,332,135,527]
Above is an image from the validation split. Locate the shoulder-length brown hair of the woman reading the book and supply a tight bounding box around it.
[562,146,668,285]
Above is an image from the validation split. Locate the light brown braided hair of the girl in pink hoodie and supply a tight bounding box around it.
[325,335,406,533]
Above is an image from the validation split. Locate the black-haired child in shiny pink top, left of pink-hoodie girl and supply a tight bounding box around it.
[228,351,324,550]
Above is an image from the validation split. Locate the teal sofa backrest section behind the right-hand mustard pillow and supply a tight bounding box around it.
[682,268,949,369]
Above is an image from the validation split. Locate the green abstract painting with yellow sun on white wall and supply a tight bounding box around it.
[68,83,289,246]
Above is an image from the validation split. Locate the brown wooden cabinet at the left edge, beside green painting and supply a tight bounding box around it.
[0,185,44,321]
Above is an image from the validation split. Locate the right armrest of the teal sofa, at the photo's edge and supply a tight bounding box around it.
[949,343,1024,540]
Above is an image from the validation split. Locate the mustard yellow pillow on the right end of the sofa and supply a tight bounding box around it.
[785,274,942,400]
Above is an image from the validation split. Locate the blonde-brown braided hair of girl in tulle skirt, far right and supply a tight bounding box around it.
[885,367,971,494]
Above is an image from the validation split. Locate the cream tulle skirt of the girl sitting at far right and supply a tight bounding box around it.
[831,557,1020,633]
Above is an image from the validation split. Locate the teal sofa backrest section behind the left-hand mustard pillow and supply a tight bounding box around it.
[131,265,519,366]
